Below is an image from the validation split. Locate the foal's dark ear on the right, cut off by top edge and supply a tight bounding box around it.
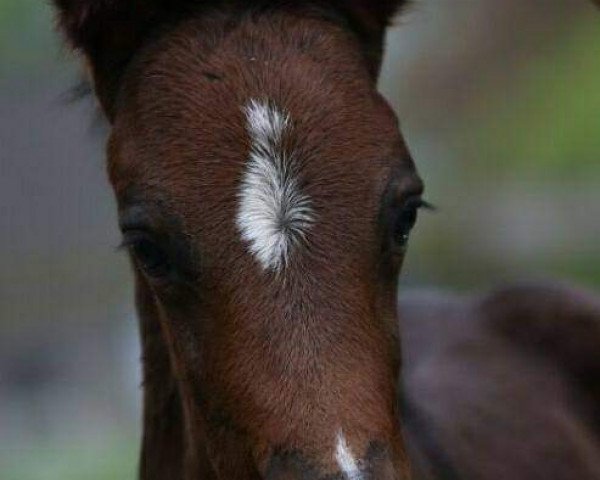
[330,0,410,77]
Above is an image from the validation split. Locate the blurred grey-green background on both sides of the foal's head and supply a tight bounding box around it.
[0,0,600,480]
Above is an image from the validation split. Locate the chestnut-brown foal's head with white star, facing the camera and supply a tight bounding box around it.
[54,0,591,480]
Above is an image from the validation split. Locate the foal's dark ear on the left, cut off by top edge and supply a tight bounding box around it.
[53,0,162,118]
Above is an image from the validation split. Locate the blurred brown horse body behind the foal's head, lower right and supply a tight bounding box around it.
[399,284,600,480]
